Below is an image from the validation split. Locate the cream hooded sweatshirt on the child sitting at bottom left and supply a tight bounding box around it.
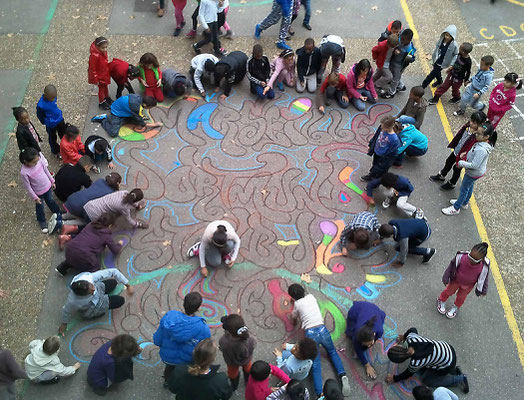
[24,339,76,380]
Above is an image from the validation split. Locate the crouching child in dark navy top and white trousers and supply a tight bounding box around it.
[366,172,424,218]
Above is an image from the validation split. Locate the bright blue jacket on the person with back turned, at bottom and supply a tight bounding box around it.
[153,310,211,364]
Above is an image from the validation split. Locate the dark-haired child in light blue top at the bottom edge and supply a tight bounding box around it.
[273,337,318,381]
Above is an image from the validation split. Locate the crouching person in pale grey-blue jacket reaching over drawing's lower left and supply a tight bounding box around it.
[58,268,133,336]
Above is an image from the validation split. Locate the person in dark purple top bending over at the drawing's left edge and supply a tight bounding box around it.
[56,214,124,275]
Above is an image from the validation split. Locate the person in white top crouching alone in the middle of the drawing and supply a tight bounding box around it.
[187,220,240,277]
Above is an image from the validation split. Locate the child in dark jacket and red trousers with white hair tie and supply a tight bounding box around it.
[218,314,257,391]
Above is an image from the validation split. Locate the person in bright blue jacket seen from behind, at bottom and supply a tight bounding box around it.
[153,292,211,385]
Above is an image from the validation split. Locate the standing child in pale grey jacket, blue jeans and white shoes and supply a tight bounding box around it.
[442,122,496,215]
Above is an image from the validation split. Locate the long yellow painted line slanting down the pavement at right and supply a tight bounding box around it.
[400,0,524,369]
